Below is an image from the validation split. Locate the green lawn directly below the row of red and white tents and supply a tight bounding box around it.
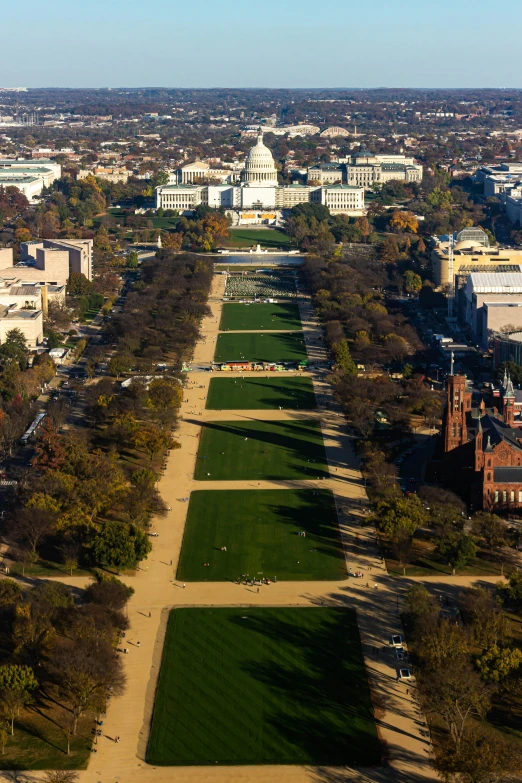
[207,373,316,411]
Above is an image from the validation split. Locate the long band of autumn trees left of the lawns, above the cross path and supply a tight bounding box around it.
[5,251,212,571]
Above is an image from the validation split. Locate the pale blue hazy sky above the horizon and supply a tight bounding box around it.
[4,0,522,87]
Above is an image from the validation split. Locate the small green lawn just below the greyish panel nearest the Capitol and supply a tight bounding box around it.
[219,302,301,332]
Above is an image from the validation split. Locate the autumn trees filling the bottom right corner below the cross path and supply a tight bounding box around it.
[403,574,522,783]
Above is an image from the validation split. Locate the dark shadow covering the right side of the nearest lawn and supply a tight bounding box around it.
[230,609,381,766]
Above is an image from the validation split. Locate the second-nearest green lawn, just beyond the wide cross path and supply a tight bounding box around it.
[177,489,346,582]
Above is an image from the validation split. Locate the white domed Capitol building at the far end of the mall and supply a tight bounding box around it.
[156,131,365,225]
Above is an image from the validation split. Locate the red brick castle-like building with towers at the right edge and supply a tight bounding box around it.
[443,375,522,511]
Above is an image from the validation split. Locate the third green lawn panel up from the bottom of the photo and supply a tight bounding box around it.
[194,421,329,481]
